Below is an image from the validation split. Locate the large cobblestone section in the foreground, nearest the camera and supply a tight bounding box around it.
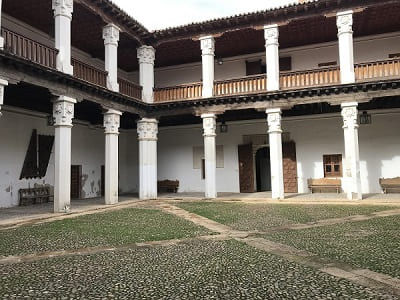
[0,241,395,299]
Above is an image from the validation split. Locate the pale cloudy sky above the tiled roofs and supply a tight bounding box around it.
[112,0,295,30]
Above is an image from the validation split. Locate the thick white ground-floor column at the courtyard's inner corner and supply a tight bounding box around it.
[137,118,158,200]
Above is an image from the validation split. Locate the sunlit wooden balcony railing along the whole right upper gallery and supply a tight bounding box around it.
[154,59,400,102]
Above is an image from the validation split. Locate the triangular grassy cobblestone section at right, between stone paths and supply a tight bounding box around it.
[265,216,400,278]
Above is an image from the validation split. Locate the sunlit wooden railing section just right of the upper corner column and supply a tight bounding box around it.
[154,82,203,102]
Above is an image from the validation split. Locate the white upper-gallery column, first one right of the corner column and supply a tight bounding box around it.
[200,36,215,98]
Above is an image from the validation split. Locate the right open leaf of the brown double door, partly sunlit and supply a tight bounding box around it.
[282,142,298,193]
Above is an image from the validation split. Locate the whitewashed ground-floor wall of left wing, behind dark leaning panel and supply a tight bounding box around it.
[0,107,138,207]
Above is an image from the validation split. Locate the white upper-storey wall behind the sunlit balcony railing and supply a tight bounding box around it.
[155,32,400,87]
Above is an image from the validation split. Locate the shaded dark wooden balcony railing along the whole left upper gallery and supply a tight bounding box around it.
[1,28,142,100]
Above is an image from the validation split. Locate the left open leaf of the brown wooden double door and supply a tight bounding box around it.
[238,144,254,193]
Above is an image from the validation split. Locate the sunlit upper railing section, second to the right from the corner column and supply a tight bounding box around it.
[214,74,267,96]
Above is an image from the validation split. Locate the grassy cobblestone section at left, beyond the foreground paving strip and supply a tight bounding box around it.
[0,208,210,257]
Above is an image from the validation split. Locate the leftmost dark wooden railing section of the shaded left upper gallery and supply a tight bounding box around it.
[1,28,57,68]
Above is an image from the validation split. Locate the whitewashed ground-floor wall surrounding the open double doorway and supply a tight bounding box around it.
[158,112,400,193]
